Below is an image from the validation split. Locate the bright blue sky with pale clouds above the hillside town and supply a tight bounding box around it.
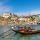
[0,0,40,15]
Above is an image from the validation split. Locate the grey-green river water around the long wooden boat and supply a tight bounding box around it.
[0,25,40,40]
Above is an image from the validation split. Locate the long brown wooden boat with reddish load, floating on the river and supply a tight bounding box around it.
[12,27,40,34]
